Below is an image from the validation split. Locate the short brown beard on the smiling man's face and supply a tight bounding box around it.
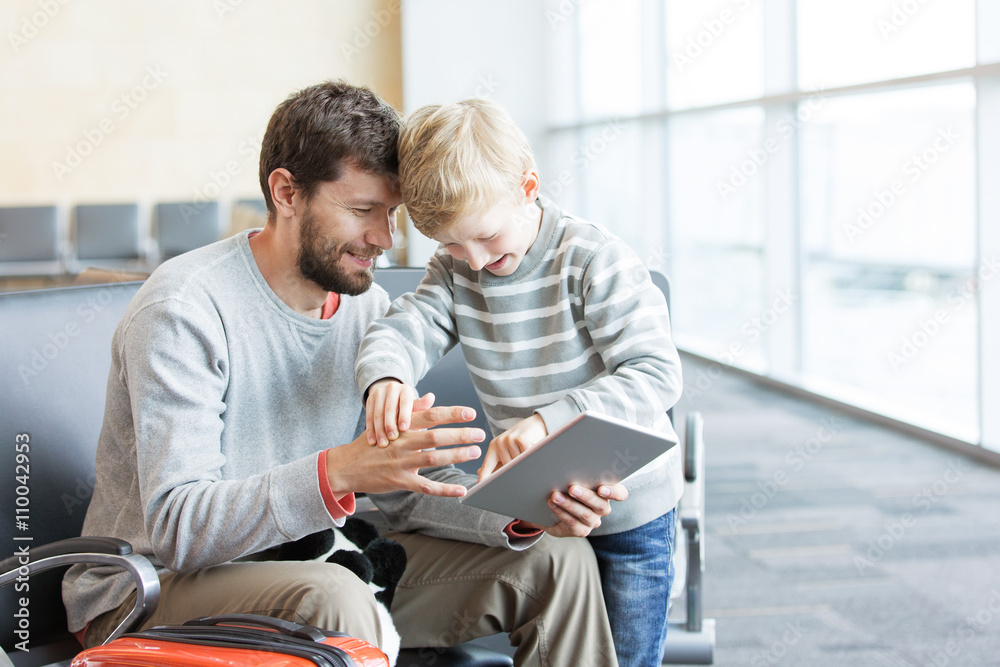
[298,210,382,296]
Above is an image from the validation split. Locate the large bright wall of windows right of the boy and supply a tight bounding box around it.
[542,0,1000,449]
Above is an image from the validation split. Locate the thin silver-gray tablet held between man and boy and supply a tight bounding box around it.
[461,412,677,526]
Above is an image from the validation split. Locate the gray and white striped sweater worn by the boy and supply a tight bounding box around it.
[355,200,682,534]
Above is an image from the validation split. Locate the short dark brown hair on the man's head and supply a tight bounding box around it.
[260,81,400,217]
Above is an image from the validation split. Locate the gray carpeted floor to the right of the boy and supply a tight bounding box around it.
[676,357,1000,667]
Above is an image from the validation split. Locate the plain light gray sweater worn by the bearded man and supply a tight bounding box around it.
[63,233,530,632]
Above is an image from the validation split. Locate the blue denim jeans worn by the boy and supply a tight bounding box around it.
[588,510,675,667]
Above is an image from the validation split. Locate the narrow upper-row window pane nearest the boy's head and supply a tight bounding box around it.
[579,0,642,118]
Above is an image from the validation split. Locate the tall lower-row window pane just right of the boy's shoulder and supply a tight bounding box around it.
[667,107,764,369]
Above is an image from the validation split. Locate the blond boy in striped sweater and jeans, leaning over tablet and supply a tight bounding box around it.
[356,100,682,666]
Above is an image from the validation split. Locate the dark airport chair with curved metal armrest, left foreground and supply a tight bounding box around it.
[0,282,512,667]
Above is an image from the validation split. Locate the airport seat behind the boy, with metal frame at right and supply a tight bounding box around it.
[372,268,715,665]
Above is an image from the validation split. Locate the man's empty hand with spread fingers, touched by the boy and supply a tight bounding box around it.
[326,404,486,498]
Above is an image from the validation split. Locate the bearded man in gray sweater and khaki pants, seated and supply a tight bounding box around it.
[63,82,615,665]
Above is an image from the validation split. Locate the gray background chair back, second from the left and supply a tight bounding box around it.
[72,204,144,269]
